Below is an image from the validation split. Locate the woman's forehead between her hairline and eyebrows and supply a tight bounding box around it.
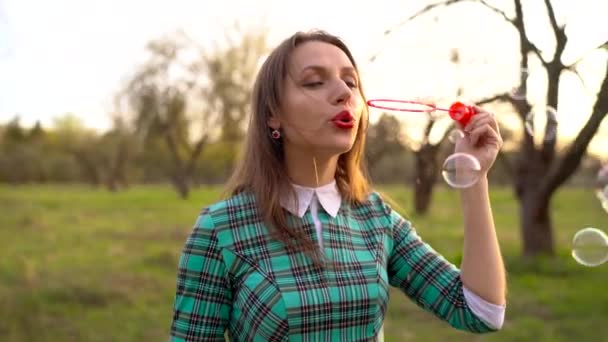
[291,41,353,70]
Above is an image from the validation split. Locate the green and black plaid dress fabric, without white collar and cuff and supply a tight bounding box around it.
[171,192,494,341]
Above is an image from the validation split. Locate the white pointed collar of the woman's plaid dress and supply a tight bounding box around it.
[281,180,342,218]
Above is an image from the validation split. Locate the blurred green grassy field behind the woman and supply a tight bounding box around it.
[0,186,608,342]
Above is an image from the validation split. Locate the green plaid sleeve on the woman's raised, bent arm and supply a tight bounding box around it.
[385,200,497,333]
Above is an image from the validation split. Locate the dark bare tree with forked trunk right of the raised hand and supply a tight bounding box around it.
[387,0,608,256]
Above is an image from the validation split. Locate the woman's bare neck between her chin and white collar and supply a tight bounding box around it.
[285,146,339,188]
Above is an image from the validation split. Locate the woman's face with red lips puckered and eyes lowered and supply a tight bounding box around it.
[269,41,364,155]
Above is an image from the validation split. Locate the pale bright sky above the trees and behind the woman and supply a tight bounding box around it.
[0,0,608,155]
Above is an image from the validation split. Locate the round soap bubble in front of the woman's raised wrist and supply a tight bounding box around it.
[441,152,481,189]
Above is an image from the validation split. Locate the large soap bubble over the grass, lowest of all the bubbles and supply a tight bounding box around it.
[572,227,608,267]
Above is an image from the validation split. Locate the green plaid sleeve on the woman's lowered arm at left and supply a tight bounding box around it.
[171,211,232,341]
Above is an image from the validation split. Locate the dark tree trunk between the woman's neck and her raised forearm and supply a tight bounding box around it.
[414,144,438,215]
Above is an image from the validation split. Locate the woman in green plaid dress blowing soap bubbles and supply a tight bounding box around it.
[171,31,505,341]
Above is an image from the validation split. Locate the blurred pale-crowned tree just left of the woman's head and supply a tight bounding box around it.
[119,26,265,198]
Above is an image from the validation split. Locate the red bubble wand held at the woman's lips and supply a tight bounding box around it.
[367,99,477,126]
